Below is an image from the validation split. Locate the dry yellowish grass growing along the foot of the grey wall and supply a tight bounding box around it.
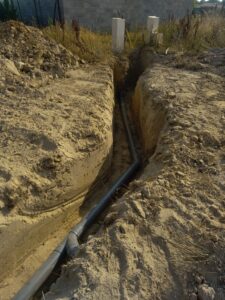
[43,12,225,63]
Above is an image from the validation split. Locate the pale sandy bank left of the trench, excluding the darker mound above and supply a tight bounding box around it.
[1,68,113,213]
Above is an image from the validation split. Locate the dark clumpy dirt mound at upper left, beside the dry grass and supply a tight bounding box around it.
[0,21,81,77]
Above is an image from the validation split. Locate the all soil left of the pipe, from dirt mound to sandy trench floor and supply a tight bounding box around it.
[0,22,114,299]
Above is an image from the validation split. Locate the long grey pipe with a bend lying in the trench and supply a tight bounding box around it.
[13,94,140,300]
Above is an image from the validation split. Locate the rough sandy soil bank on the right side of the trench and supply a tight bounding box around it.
[45,51,225,300]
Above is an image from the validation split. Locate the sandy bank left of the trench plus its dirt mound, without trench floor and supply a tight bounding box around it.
[0,22,114,213]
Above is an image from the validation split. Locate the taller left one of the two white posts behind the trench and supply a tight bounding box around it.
[112,18,125,52]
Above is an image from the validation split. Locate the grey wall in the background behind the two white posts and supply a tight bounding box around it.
[62,0,192,30]
